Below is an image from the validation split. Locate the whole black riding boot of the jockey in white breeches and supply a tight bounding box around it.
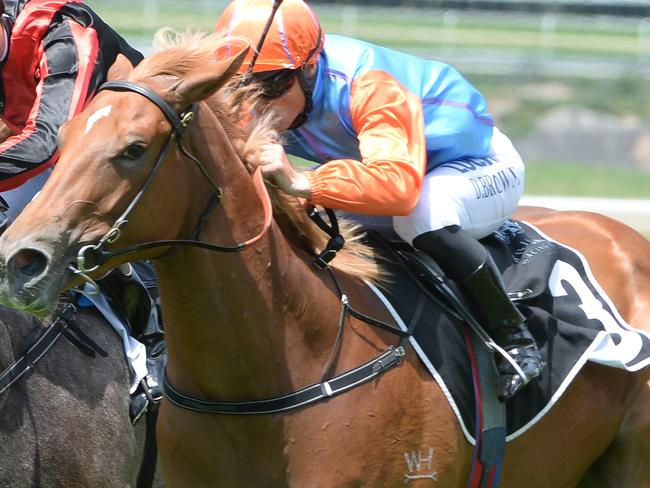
[413,226,544,402]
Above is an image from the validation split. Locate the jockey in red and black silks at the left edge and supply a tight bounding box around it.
[0,0,163,420]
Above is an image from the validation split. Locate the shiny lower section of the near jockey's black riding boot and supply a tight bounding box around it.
[461,258,544,402]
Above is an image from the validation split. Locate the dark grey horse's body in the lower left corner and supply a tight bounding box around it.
[0,307,160,488]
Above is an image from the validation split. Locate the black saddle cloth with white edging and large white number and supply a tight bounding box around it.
[369,221,650,443]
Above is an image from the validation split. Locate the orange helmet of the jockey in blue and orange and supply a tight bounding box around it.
[216,0,324,73]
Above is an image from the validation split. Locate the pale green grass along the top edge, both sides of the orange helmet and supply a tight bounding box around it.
[87,0,650,58]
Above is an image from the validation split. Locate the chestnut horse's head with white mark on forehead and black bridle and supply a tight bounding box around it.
[0,34,246,315]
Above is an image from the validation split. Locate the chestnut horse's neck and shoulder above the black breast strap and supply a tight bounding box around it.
[157,107,340,398]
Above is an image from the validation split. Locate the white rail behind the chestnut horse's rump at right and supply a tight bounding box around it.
[521,196,650,236]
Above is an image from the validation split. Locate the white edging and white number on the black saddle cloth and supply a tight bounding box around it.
[366,221,650,445]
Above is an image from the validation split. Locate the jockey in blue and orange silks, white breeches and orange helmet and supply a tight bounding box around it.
[217,0,544,401]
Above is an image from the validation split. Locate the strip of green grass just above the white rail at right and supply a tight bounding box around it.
[525,162,650,199]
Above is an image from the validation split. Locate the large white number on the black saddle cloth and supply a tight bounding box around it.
[548,261,643,367]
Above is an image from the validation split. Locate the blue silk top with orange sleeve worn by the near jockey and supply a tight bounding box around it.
[286,35,494,215]
